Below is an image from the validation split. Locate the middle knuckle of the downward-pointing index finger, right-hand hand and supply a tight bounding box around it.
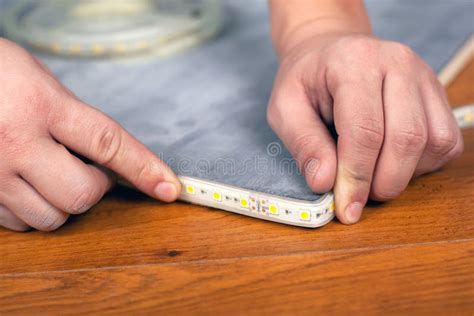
[350,119,384,150]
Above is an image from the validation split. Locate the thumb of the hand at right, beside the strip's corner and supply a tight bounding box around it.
[267,81,337,193]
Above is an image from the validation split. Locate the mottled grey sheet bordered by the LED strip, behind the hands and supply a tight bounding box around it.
[0,0,474,200]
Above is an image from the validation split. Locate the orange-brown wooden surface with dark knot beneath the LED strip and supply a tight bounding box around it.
[0,61,474,315]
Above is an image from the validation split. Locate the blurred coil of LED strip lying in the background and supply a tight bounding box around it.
[2,0,221,57]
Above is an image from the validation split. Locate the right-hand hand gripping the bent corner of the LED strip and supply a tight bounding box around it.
[268,29,463,224]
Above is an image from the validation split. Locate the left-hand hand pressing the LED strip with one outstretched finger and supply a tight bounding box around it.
[0,39,180,231]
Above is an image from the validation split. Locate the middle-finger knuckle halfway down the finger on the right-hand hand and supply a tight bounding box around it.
[393,123,427,154]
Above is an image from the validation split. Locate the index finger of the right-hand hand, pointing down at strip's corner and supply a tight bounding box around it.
[332,77,384,224]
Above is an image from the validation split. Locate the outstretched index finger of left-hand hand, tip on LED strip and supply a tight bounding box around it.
[48,97,180,202]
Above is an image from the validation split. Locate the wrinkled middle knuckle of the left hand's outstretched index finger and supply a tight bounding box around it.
[92,123,122,167]
